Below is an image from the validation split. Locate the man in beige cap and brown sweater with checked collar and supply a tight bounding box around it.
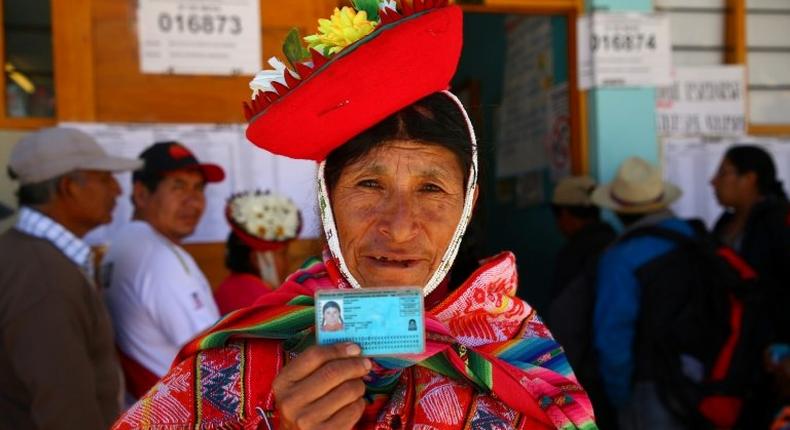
[0,128,142,429]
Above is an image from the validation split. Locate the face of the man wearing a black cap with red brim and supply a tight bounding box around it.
[134,170,206,242]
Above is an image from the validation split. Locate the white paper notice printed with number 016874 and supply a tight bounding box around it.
[576,13,672,89]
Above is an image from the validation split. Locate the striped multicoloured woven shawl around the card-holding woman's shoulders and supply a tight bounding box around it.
[175,253,597,430]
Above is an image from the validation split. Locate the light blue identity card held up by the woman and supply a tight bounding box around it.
[315,287,425,356]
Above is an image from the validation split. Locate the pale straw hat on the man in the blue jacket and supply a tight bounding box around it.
[592,157,682,214]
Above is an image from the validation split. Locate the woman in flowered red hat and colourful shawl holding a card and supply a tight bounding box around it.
[111,0,596,429]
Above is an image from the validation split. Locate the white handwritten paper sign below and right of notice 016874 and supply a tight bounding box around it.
[656,66,746,136]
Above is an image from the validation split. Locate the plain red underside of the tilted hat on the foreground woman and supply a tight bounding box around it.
[247,6,463,161]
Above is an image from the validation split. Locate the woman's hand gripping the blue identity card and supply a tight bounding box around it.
[272,343,372,430]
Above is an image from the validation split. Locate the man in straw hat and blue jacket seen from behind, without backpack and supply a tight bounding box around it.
[592,158,695,430]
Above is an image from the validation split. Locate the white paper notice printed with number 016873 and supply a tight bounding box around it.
[137,0,262,75]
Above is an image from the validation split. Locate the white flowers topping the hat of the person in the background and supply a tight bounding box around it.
[229,191,301,242]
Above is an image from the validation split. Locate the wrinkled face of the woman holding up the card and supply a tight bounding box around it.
[331,141,465,287]
